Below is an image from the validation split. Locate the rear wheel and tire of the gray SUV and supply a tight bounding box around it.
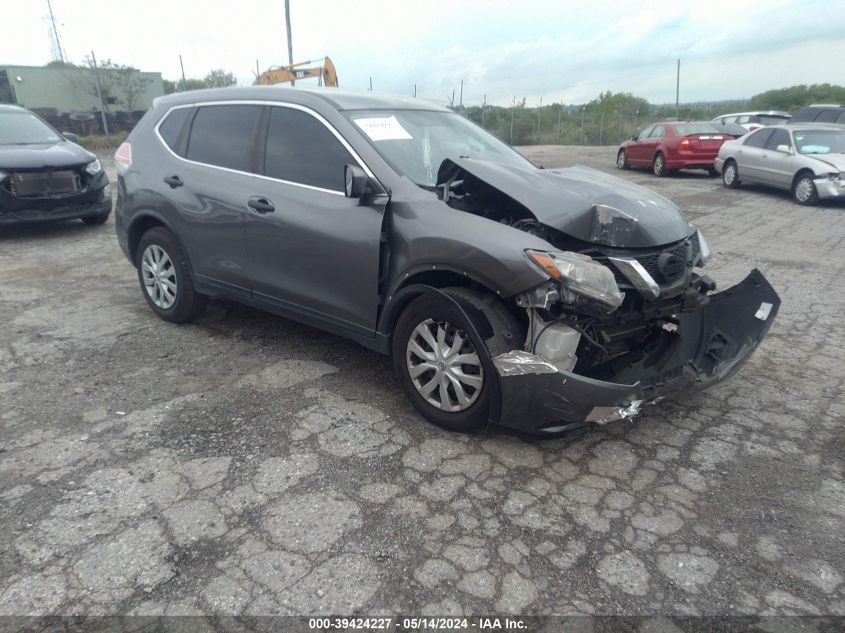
[135,226,208,323]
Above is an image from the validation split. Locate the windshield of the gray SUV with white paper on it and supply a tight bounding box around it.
[346,110,533,187]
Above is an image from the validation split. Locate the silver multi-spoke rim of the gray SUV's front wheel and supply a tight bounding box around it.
[405,319,484,412]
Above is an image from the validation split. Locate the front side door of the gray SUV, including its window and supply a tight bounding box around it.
[241,104,387,336]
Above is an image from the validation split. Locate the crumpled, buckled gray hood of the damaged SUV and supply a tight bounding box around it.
[437,158,694,248]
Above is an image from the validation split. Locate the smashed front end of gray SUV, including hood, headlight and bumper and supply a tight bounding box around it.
[438,153,780,433]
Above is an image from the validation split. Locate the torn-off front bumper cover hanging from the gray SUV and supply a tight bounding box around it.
[493,269,780,434]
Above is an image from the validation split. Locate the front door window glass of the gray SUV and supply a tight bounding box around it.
[264,106,357,191]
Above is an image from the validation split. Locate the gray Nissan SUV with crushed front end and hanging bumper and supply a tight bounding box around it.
[115,86,780,434]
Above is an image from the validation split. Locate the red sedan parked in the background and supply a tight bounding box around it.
[616,121,732,176]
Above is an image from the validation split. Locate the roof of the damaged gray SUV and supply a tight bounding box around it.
[155,86,450,112]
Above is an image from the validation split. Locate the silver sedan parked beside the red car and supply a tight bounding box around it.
[716,123,845,204]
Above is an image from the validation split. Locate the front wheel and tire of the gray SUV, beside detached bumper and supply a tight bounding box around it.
[393,288,496,432]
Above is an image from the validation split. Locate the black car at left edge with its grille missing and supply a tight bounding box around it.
[0,105,112,224]
